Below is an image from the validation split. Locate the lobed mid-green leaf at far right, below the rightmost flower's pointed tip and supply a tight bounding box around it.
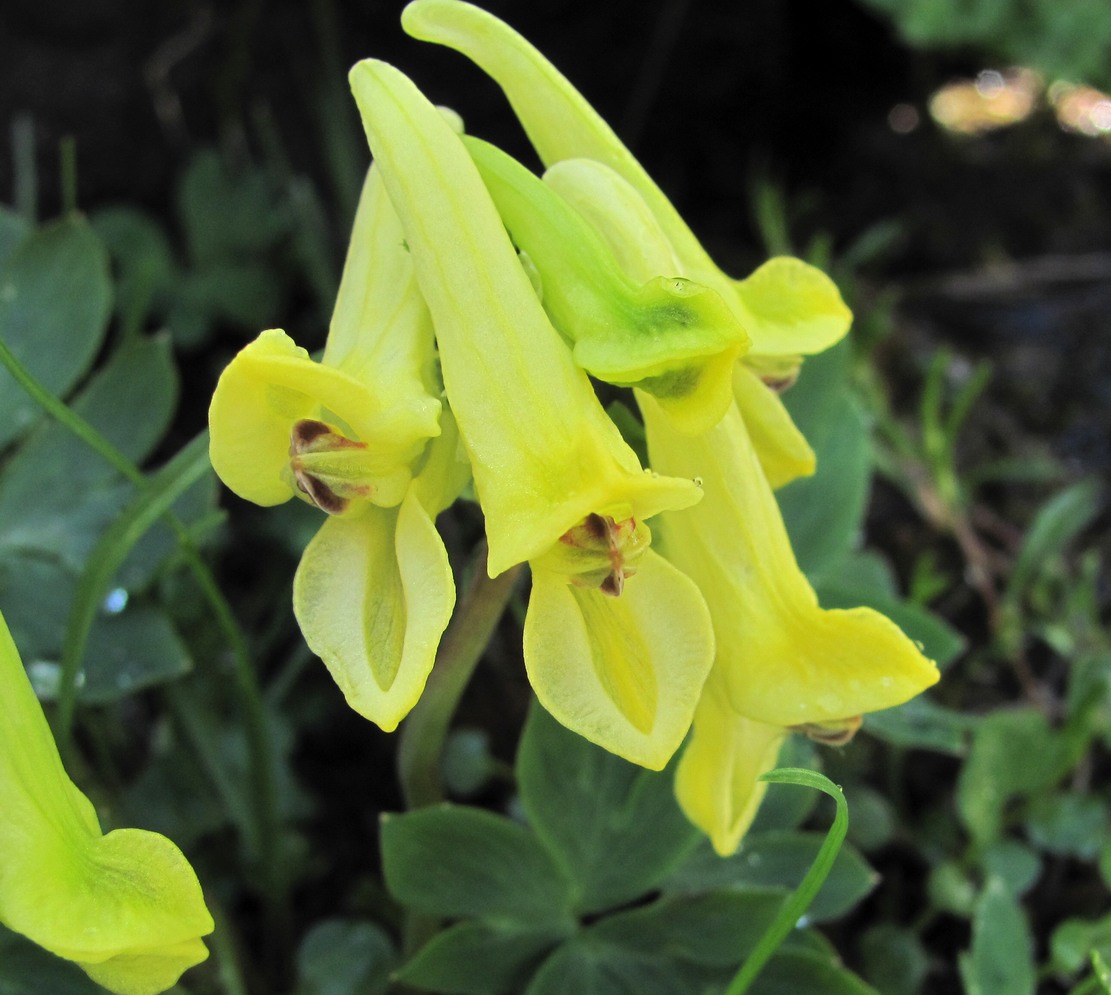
[957,708,1071,845]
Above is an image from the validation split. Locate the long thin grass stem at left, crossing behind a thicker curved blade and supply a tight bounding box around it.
[0,333,284,923]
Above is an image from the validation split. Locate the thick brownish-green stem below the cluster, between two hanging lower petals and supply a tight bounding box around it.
[398,545,522,808]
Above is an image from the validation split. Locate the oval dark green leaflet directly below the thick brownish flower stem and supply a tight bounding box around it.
[382,805,571,925]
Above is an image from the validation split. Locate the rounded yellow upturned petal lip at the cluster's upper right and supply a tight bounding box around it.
[735,255,852,364]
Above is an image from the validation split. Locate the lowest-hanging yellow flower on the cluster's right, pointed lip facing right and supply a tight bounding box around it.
[640,385,938,853]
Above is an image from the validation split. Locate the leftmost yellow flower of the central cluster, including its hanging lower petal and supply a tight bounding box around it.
[209,170,457,732]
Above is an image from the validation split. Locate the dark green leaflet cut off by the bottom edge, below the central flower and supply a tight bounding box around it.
[524,936,698,995]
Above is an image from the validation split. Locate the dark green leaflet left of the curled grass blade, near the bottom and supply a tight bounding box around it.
[590,887,788,968]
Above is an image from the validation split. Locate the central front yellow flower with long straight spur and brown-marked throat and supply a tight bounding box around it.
[351,60,713,767]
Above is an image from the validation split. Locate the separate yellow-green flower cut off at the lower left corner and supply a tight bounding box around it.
[0,616,212,995]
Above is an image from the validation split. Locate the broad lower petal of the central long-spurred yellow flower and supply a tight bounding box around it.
[524,550,713,770]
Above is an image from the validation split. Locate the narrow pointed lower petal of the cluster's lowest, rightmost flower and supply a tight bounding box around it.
[675,676,787,856]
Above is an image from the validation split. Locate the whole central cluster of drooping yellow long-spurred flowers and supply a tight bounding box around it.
[210,0,937,853]
